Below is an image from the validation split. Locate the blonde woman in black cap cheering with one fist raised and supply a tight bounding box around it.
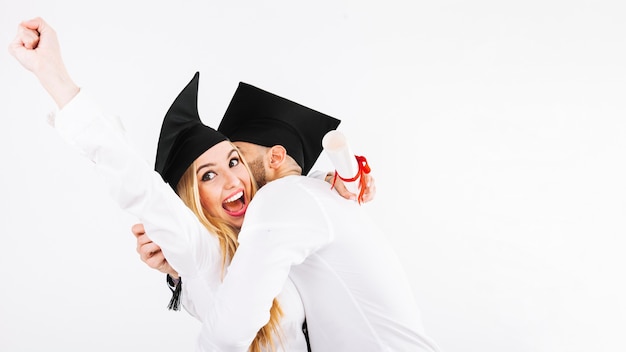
[9,18,358,351]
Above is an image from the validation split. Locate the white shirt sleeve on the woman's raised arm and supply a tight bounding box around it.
[53,89,219,276]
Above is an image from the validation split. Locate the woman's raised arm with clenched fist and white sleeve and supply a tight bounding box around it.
[9,18,221,275]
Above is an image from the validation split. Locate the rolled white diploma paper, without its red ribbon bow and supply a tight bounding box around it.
[322,130,360,195]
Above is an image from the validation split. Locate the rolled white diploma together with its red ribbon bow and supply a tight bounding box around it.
[322,130,370,203]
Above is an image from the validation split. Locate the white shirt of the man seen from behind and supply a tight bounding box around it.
[196,176,439,352]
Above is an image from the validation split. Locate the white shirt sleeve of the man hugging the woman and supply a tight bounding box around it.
[199,180,333,352]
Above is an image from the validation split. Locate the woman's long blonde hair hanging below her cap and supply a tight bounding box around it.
[176,148,283,352]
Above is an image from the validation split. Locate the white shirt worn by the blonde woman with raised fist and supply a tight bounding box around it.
[53,90,307,352]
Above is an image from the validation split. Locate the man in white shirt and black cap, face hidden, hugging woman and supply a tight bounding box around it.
[190,84,438,351]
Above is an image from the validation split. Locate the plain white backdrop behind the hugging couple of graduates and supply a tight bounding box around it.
[0,0,626,352]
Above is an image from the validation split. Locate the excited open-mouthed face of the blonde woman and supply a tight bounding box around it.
[194,141,252,228]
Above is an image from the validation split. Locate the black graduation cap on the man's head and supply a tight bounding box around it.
[217,82,341,175]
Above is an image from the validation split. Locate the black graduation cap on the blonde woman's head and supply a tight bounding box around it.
[154,72,228,190]
